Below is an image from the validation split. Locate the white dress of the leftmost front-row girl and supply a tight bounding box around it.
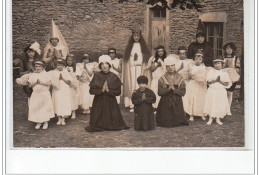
[28,71,55,123]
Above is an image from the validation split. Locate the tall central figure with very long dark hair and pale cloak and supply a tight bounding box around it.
[122,30,152,112]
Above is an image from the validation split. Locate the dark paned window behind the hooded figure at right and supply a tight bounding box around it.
[204,22,223,57]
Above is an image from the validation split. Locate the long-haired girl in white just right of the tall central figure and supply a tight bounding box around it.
[148,46,167,110]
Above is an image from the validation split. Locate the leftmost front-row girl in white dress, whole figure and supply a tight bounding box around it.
[28,61,55,129]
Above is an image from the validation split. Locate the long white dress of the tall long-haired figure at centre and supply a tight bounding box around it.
[124,43,143,108]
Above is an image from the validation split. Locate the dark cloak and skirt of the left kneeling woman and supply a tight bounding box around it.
[86,71,129,132]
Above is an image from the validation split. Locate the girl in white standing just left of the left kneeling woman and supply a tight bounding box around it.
[76,54,95,114]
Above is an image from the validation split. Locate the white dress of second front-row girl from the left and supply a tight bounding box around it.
[49,68,72,117]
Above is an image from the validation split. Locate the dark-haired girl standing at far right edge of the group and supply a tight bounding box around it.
[223,43,240,107]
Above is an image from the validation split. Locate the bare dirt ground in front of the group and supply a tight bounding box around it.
[13,83,244,148]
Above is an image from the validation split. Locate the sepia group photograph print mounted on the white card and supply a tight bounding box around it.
[10,0,246,148]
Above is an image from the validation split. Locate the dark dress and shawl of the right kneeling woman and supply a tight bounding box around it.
[156,72,189,127]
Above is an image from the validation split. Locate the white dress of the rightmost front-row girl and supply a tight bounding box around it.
[204,69,232,118]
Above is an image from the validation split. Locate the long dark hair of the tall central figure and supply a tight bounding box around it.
[124,33,151,63]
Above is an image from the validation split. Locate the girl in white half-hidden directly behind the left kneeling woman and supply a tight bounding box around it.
[108,48,122,104]
